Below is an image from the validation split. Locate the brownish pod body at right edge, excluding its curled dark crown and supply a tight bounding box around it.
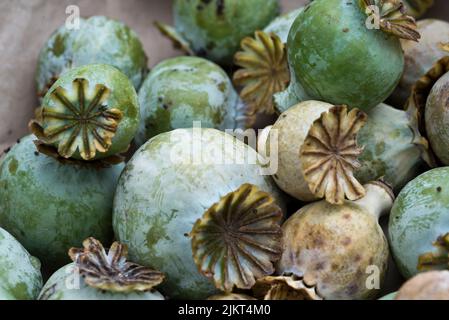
[425,72,449,165]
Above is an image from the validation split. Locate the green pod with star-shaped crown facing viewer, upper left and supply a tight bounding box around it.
[30,64,140,160]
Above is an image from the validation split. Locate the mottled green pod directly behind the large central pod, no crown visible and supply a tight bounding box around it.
[136,57,245,145]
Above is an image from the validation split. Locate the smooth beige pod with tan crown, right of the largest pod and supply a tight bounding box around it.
[259,101,366,204]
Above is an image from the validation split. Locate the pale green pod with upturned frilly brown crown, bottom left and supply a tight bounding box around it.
[39,238,164,300]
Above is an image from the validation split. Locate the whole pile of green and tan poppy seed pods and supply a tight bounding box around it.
[0,0,449,300]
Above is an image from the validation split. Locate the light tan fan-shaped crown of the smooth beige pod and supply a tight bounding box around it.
[299,106,367,205]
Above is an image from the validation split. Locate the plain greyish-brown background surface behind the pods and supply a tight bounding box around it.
[0,0,449,151]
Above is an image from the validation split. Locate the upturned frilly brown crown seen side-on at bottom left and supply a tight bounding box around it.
[69,238,165,292]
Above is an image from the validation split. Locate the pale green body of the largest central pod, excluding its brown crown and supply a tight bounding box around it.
[113,129,284,299]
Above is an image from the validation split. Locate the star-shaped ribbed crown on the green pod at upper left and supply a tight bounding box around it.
[29,78,123,160]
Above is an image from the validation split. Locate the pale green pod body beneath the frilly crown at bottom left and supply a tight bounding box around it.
[38,263,164,300]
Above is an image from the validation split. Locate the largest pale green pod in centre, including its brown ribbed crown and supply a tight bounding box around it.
[113,129,284,299]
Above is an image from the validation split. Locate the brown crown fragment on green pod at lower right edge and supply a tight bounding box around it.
[418,233,449,271]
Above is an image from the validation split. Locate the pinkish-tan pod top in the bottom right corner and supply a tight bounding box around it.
[395,271,449,300]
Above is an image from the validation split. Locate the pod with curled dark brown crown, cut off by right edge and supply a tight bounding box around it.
[407,56,449,167]
